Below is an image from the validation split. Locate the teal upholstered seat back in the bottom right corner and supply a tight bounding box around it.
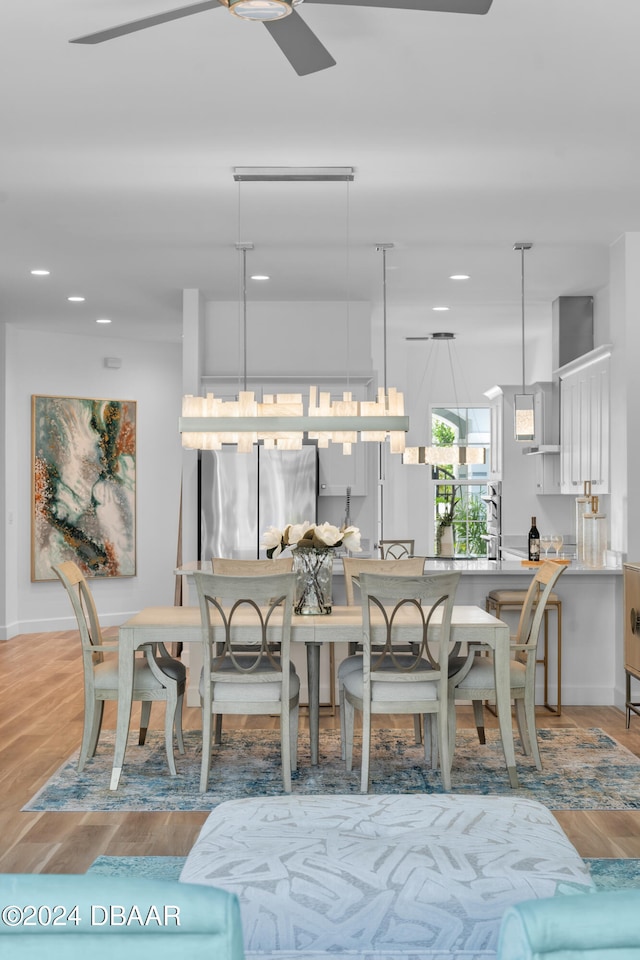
[498,889,640,960]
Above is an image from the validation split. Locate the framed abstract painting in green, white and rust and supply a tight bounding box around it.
[31,396,136,581]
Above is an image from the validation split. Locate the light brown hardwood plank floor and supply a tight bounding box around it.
[0,633,640,873]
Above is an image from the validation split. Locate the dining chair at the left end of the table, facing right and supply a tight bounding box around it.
[52,561,186,777]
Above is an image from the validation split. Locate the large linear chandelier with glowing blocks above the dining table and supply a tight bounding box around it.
[179,167,409,454]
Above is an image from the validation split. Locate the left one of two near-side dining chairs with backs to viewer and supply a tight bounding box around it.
[194,561,300,793]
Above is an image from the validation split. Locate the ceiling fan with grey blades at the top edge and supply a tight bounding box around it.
[69,0,493,77]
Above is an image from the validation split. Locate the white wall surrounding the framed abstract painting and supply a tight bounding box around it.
[0,326,181,639]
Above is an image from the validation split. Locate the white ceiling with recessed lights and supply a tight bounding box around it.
[0,0,640,348]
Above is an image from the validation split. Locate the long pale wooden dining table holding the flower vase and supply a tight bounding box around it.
[110,604,519,790]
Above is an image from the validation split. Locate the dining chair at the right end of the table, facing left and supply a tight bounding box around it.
[450,560,566,770]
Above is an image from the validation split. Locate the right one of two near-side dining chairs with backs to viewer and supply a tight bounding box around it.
[344,572,460,793]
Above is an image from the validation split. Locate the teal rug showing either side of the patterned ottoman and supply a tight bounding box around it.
[87,857,640,890]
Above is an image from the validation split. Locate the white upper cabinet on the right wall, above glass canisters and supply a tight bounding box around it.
[558,346,611,496]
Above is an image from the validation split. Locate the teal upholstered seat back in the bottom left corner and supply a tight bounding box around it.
[0,874,244,960]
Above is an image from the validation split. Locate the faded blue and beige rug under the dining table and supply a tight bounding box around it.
[22,728,640,812]
